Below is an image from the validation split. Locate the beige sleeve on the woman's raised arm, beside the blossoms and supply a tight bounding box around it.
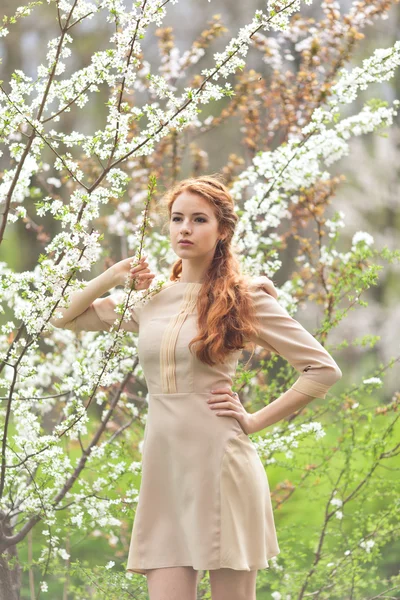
[59,292,139,333]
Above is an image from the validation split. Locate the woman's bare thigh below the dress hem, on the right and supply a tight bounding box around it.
[209,569,257,600]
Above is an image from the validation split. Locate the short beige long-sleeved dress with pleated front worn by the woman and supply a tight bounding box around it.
[61,276,341,574]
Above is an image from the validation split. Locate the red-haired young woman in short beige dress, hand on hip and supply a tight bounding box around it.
[52,176,342,600]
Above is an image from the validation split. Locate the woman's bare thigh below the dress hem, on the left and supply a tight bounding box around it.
[147,567,198,600]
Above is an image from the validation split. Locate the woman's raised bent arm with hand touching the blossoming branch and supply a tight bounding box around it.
[50,256,155,332]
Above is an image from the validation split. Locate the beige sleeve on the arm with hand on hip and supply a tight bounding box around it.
[250,275,342,398]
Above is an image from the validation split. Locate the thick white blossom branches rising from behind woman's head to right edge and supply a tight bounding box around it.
[231,43,400,275]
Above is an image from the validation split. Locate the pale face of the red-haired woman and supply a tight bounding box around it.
[169,191,222,259]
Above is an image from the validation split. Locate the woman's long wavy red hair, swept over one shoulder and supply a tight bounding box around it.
[162,175,264,365]
